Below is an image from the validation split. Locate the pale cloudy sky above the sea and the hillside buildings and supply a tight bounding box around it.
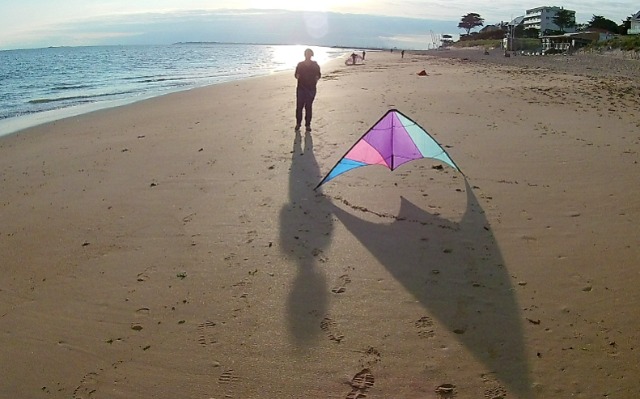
[0,0,640,50]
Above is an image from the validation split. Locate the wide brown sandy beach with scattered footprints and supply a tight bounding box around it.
[0,50,640,399]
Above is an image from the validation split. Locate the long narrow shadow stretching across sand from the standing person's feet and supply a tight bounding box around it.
[279,132,333,347]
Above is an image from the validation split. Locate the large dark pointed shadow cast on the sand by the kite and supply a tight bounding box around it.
[333,179,530,397]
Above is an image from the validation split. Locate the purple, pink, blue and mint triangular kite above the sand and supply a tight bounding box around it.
[316,109,462,189]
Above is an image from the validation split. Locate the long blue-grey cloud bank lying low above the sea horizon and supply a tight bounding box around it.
[1,10,457,49]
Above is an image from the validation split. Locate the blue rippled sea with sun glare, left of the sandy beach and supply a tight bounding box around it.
[0,43,346,136]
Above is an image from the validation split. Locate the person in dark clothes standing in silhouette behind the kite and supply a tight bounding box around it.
[294,48,322,132]
